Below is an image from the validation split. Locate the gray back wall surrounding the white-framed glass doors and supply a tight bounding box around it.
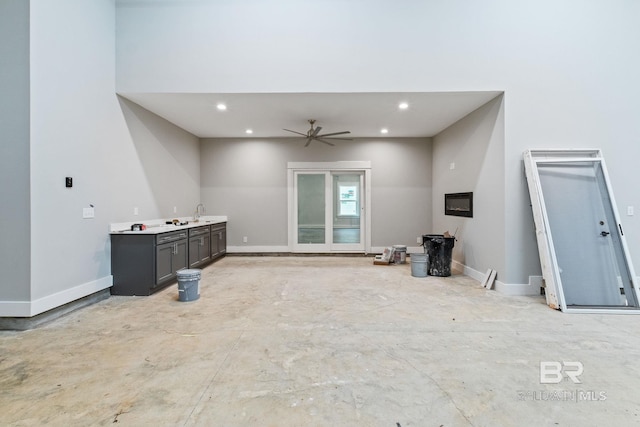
[201,138,431,251]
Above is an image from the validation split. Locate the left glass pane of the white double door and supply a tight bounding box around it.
[296,173,326,245]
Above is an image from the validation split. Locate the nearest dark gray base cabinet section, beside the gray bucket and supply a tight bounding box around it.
[111,230,188,295]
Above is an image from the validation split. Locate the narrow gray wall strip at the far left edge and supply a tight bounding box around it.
[0,0,31,302]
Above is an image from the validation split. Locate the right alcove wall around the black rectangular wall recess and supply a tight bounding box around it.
[433,95,505,279]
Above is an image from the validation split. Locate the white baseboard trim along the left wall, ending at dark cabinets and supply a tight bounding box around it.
[0,275,113,317]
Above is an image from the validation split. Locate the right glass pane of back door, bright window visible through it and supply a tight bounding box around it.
[331,172,364,250]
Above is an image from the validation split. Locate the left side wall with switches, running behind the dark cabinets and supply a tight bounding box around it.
[0,0,200,316]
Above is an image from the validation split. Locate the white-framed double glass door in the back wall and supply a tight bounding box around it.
[289,162,370,253]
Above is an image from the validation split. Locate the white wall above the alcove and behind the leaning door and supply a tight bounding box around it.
[117,0,640,283]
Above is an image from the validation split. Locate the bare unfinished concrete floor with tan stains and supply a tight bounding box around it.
[0,256,640,427]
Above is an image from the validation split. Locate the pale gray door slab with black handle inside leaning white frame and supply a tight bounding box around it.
[538,161,638,308]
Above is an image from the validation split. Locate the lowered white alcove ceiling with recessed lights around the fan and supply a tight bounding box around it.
[120,91,501,138]
